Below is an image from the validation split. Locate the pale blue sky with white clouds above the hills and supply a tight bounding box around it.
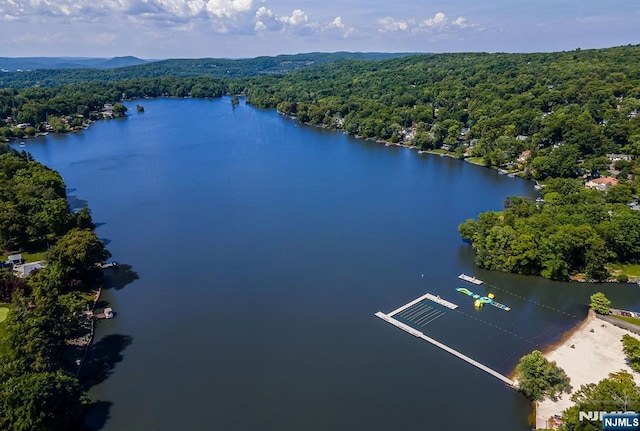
[0,0,640,59]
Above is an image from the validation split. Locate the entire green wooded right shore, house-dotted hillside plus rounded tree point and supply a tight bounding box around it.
[236,46,640,281]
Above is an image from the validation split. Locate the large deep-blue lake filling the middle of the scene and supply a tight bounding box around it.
[15,98,640,431]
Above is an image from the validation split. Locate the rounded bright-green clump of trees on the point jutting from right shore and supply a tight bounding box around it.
[458,184,640,280]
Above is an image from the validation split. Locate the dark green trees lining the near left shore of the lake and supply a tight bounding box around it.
[0,145,109,431]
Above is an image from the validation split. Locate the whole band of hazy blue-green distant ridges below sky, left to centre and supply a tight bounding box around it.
[0,52,414,88]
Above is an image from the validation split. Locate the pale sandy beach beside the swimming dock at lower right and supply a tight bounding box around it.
[536,311,640,428]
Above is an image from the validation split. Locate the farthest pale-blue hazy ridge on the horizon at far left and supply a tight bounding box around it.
[0,56,150,72]
